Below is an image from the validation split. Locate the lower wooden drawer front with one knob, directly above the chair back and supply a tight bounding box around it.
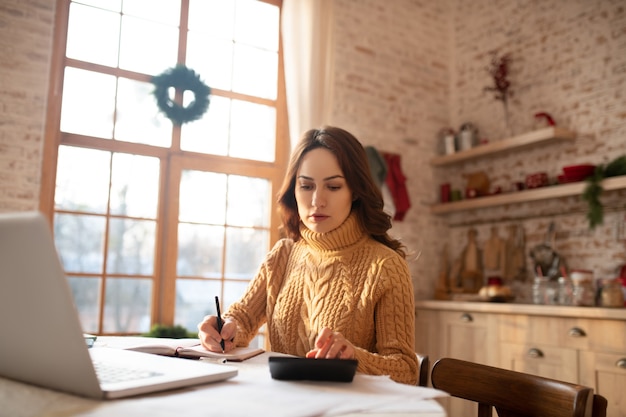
[500,343,579,384]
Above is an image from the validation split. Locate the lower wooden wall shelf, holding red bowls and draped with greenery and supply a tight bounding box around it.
[430,175,626,214]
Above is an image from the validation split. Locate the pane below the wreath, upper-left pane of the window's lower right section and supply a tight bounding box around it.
[179,170,226,225]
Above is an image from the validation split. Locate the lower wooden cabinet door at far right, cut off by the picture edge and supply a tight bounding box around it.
[580,349,626,417]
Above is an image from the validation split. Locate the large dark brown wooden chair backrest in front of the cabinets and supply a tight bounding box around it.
[430,358,592,417]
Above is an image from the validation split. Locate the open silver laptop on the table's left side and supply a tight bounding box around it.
[0,212,237,399]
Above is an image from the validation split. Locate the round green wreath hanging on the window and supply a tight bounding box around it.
[152,65,211,125]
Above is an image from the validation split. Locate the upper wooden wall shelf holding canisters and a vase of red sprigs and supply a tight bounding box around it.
[430,126,576,166]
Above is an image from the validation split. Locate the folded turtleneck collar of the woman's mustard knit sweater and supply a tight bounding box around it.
[300,212,365,251]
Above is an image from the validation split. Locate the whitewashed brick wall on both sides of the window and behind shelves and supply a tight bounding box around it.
[0,0,626,298]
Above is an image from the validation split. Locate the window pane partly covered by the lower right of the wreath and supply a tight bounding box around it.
[180,96,231,155]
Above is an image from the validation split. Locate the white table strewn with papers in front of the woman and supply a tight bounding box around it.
[0,353,446,417]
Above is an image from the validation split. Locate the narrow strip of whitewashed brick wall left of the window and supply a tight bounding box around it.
[0,0,55,212]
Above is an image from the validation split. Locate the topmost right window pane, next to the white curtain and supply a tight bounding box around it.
[235,1,279,52]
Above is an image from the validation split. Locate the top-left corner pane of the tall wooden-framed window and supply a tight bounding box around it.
[66,3,120,67]
